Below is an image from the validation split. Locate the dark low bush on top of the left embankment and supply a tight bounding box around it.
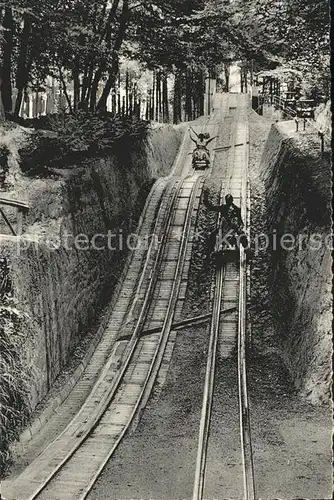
[19,112,148,175]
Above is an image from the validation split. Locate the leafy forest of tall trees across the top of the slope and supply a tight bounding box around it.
[0,0,330,123]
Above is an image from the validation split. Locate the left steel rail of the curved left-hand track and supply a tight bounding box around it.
[28,181,183,500]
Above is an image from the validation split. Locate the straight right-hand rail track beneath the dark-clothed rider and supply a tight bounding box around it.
[192,94,256,500]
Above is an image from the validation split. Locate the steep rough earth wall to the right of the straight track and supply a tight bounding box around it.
[261,124,332,402]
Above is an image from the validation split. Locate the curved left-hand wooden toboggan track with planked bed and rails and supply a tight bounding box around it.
[5,169,204,500]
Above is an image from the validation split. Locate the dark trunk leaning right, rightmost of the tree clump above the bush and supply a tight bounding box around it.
[97,0,130,110]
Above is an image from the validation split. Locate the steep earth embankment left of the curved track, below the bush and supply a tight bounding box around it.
[0,126,183,408]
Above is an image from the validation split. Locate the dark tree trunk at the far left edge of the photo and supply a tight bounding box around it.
[1,7,14,113]
